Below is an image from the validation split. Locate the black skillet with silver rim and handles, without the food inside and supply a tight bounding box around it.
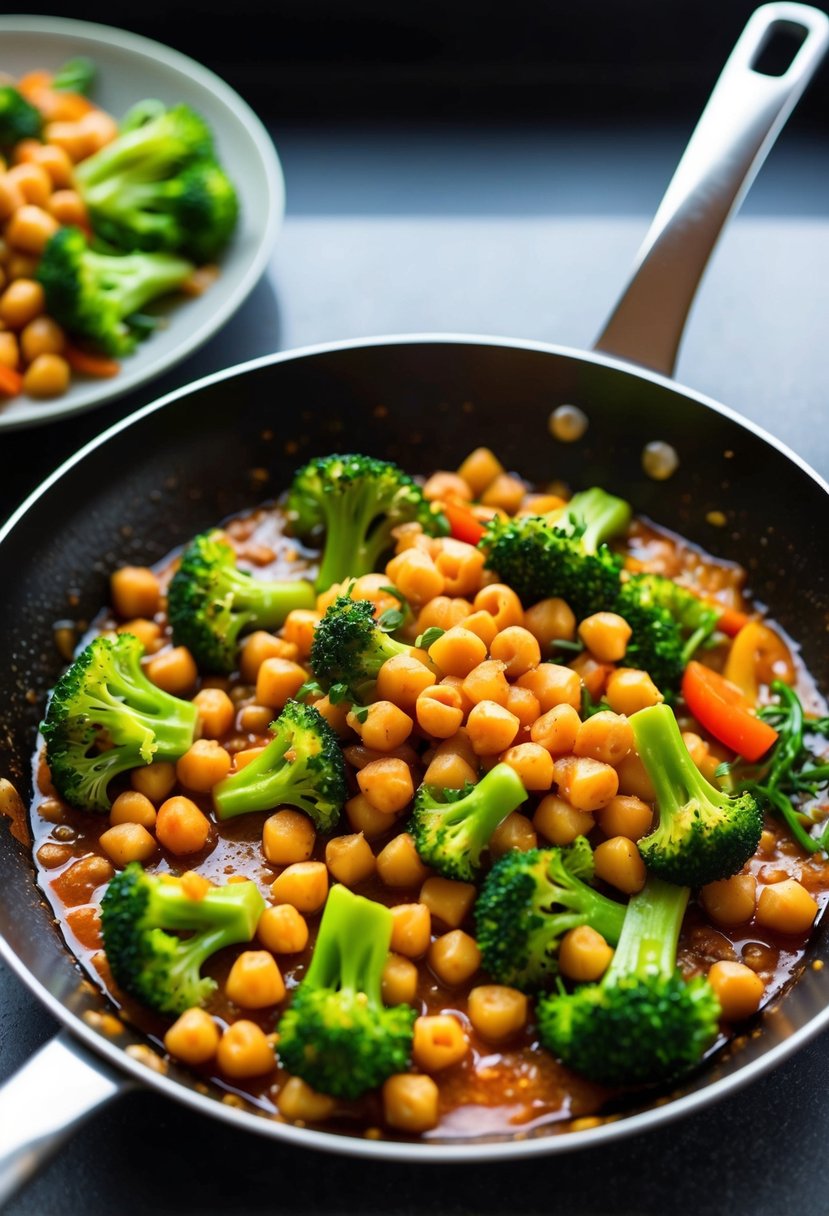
[0,4,829,1199]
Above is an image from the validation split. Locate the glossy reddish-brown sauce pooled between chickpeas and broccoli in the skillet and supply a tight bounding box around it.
[24,505,829,1139]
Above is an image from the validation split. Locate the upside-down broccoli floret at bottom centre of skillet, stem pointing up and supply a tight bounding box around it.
[277,883,416,1098]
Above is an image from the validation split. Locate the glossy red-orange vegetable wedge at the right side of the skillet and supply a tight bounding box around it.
[682,659,778,762]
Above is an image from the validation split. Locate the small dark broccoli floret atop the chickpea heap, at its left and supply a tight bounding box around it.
[310,596,413,703]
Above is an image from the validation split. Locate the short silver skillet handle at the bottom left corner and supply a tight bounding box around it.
[0,1031,134,1205]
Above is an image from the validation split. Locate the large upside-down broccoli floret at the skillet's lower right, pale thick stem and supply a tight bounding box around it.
[536,874,721,1086]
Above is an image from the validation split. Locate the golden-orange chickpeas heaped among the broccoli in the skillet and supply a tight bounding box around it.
[32,449,829,1135]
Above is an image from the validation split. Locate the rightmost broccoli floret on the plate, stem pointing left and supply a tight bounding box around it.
[83,157,239,263]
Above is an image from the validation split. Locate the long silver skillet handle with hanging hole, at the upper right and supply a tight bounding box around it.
[594,0,829,376]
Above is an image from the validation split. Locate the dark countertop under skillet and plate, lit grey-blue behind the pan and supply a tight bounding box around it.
[0,120,829,1216]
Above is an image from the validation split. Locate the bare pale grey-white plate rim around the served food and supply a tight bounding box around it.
[0,16,284,429]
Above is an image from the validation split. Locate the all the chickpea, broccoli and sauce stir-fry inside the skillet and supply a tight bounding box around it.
[25,447,829,1139]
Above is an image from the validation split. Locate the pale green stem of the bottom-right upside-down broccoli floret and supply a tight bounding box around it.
[602,874,690,985]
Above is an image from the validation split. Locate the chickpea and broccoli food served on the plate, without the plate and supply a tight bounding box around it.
[0,57,239,407]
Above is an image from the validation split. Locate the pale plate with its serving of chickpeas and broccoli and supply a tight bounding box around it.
[0,16,284,429]
